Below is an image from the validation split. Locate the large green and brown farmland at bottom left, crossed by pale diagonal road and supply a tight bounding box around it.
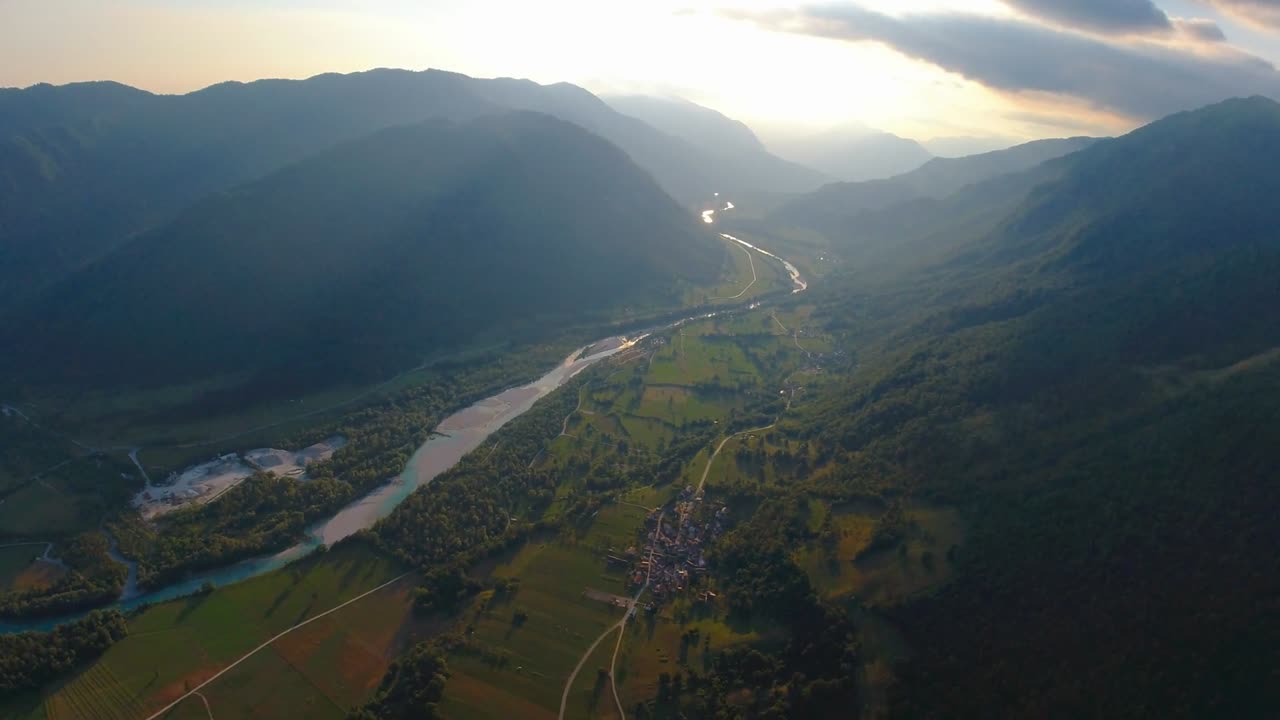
[0,543,416,720]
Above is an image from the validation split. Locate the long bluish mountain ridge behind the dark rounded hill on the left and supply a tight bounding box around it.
[0,69,773,315]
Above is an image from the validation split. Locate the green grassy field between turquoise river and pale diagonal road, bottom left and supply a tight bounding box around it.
[8,544,412,720]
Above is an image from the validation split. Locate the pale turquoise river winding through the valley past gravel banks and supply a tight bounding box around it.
[0,222,809,634]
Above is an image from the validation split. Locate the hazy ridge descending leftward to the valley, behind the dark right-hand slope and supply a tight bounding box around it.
[771,137,1094,237]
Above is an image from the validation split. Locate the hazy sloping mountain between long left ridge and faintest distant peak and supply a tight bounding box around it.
[605,95,828,192]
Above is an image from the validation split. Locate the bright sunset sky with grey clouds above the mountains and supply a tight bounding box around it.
[0,0,1280,140]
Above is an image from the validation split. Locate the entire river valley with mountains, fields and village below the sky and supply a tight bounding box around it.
[0,57,1280,720]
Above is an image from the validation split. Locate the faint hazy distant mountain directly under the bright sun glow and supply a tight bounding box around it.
[768,127,933,182]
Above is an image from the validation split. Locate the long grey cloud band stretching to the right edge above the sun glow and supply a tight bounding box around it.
[736,5,1280,119]
